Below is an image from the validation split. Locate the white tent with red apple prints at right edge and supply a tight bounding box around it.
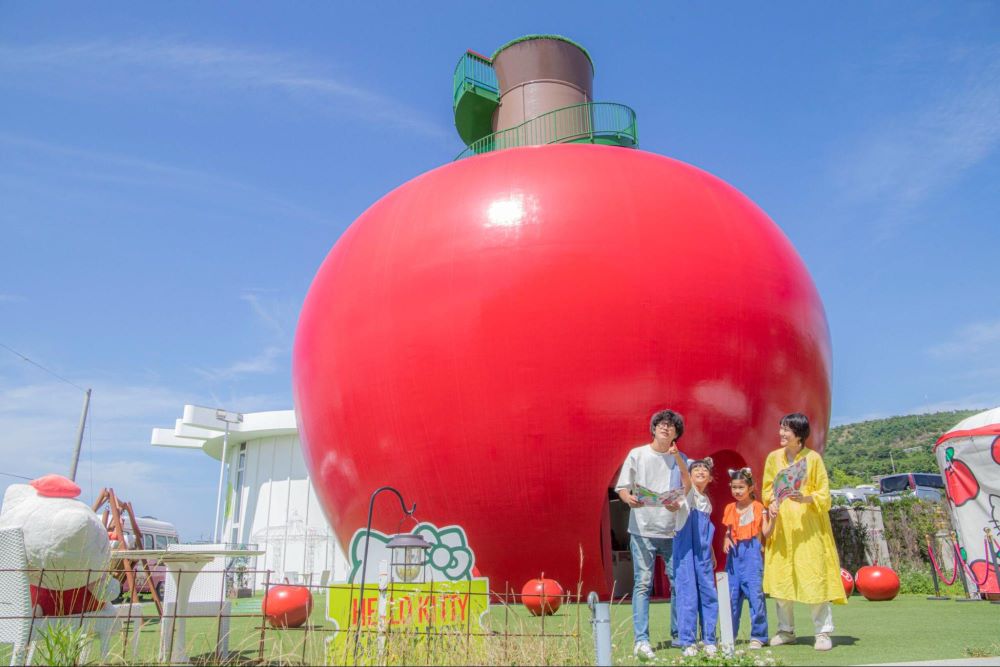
[934,408,1000,594]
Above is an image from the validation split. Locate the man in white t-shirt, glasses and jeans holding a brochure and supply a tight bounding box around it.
[615,410,687,660]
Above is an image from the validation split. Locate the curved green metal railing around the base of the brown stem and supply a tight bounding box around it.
[455,102,639,160]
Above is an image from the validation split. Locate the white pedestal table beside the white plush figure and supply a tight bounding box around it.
[111,548,264,664]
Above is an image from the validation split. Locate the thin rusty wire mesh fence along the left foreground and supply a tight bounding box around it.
[0,569,608,665]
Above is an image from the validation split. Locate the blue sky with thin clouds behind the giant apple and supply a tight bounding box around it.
[0,2,1000,539]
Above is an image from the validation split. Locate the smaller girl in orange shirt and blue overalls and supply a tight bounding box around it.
[722,468,774,649]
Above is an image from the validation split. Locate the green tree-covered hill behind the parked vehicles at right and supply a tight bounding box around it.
[823,410,981,489]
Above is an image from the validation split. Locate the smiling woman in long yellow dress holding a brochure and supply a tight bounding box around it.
[761,412,847,651]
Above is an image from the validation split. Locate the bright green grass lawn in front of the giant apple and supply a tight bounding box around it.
[0,595,1000,665]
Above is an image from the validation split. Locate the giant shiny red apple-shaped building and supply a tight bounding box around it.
[293,145,830,595]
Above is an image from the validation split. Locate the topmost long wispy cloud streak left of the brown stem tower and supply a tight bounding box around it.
[0,40,450,137]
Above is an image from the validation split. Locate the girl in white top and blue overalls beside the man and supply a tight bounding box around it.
[671,458,719,656]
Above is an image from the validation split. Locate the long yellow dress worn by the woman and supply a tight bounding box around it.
[761,447,847,604]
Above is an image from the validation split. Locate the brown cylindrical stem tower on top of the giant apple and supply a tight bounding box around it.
[493,36,594,137]
